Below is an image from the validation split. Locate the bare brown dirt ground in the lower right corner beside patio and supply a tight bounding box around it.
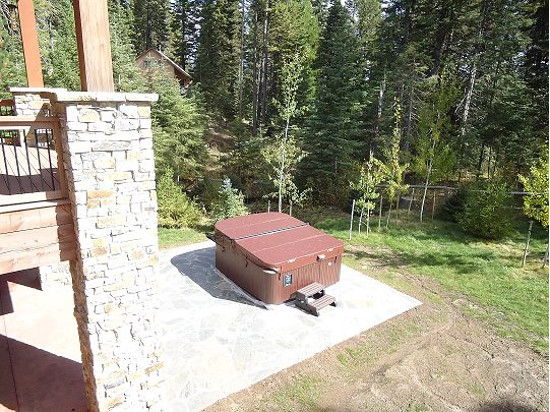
[207,246,549,412]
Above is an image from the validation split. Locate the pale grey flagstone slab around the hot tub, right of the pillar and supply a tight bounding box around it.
[159,242,421,412]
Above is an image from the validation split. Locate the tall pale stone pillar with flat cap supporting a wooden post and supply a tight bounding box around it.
[49,92,162,411]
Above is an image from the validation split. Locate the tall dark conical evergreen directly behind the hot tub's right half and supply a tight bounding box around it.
[302,2,362,204]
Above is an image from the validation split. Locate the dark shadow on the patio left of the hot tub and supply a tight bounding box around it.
[170,247,265,308]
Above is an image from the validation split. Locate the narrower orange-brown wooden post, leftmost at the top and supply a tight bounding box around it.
[17,0,44,87]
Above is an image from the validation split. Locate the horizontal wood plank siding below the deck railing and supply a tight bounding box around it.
[0,200,76,275]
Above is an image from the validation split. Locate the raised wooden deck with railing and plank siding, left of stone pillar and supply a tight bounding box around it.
[0,116,76,275]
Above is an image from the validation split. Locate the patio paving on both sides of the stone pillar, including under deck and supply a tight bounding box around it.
[0,241,421,412]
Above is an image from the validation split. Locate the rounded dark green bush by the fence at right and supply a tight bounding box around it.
[458,178,513,240]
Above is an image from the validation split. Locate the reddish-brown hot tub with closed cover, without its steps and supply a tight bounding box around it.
[213,212,344,304]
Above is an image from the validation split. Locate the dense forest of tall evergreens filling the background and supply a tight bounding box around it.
[0,0,548,232]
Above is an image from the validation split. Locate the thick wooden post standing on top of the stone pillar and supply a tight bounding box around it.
[73,0,115,92]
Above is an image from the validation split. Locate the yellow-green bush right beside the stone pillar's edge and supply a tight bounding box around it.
[157,169,204,228]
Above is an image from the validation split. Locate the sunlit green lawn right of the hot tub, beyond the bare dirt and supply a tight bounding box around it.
[313,213,548,356]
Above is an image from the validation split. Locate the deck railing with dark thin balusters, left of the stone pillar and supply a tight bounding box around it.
[0,116,67,206]
